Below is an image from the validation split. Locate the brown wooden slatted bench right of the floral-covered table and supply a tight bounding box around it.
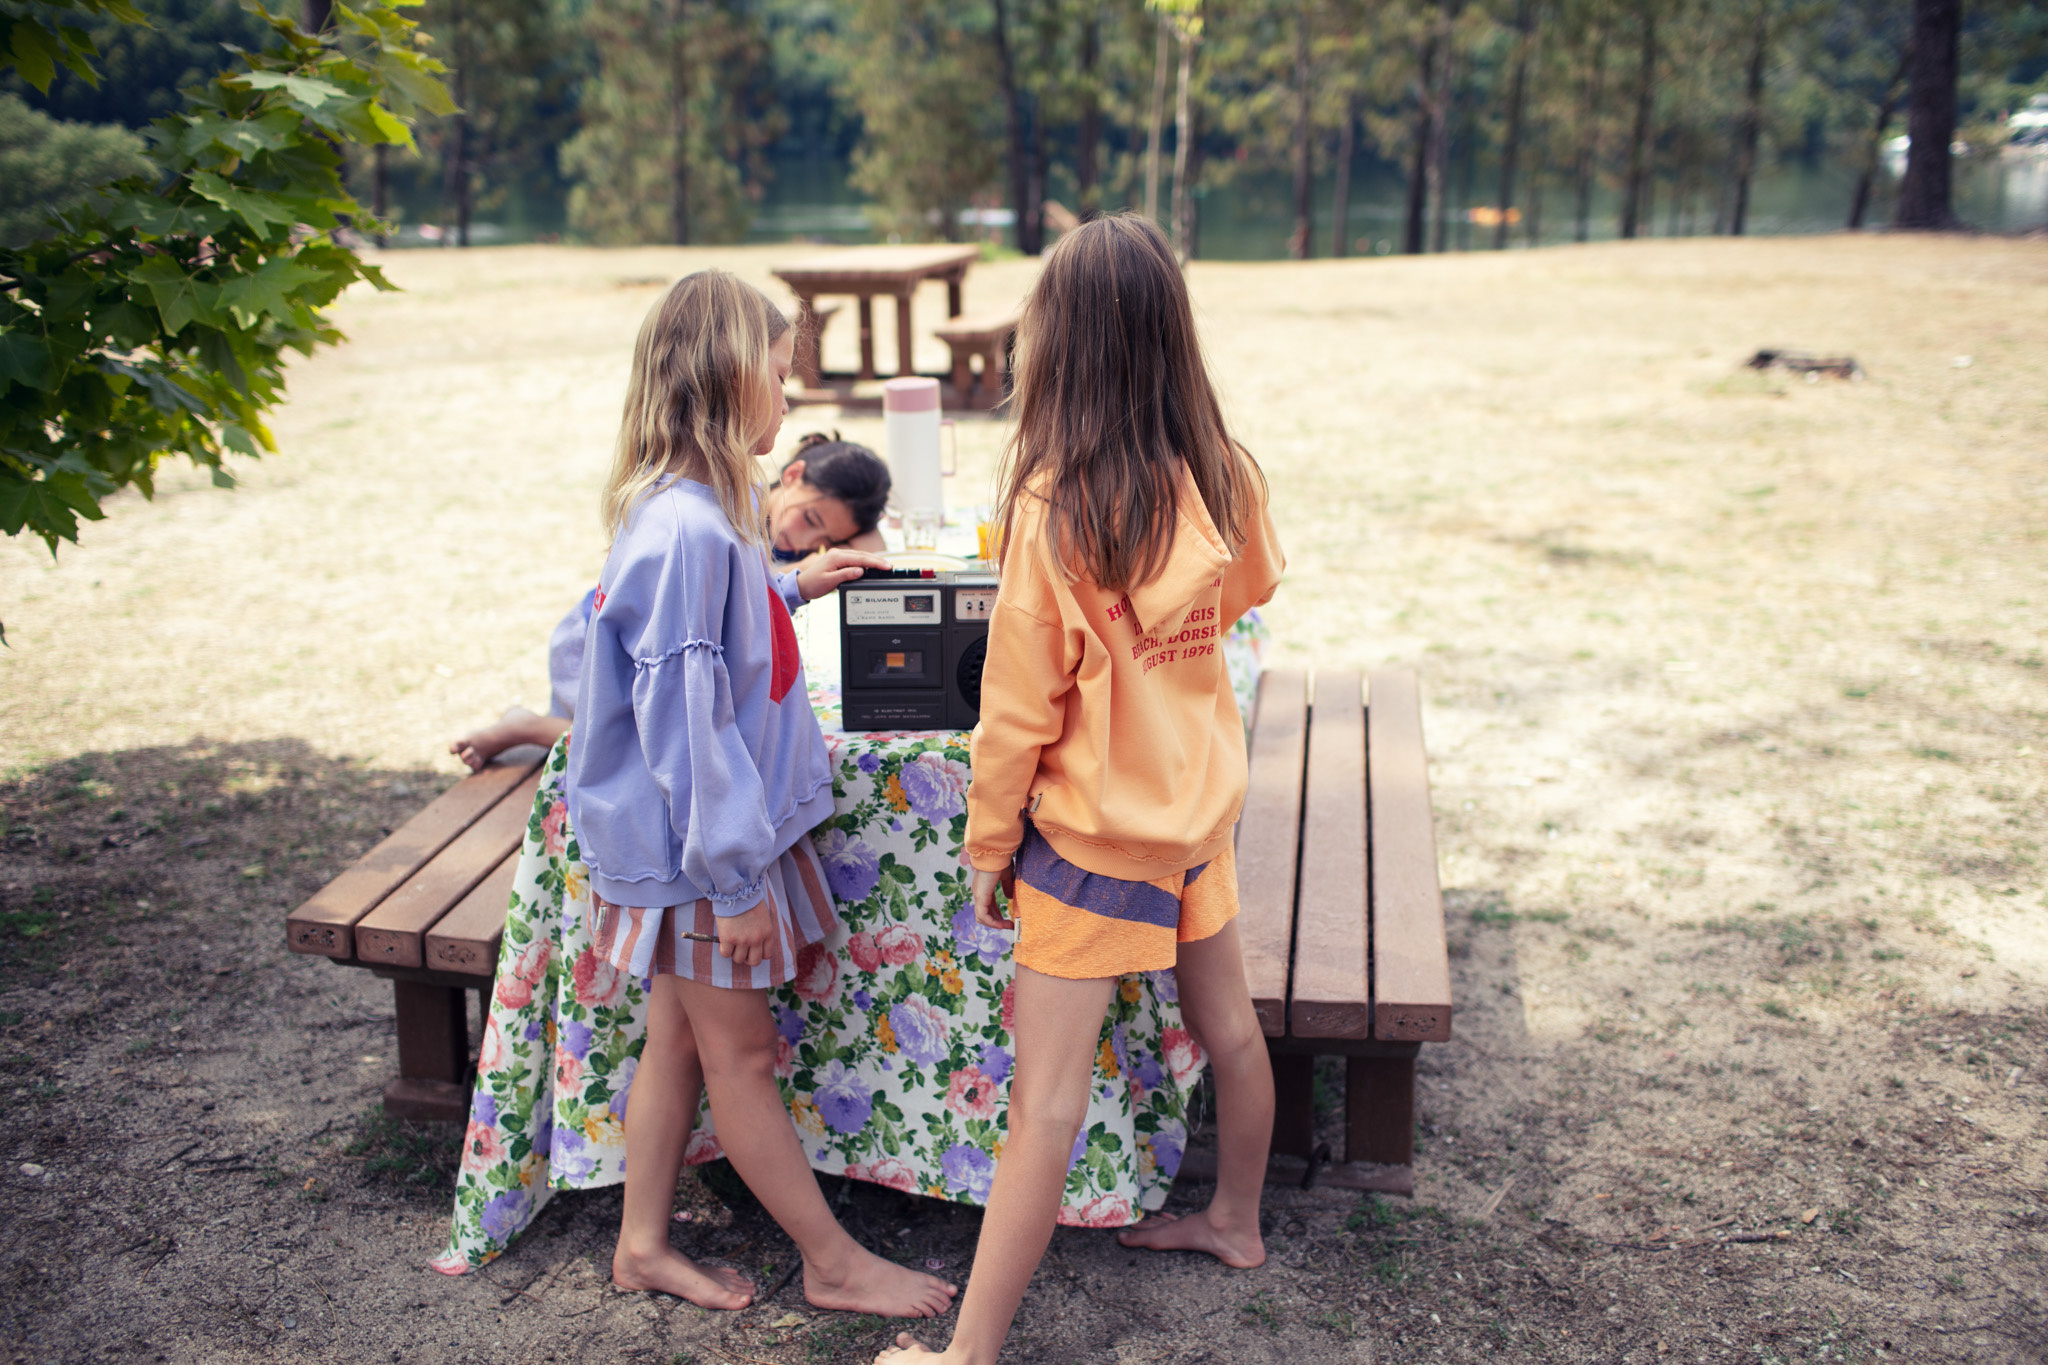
[1237,669,1450,1193]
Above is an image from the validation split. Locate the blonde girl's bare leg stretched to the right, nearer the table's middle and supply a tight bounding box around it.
[675,980,954,1318]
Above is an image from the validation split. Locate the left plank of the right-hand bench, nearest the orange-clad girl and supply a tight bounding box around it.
[1237,669,1309,1038]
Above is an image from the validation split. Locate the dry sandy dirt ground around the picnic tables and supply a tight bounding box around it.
[0,237,2048,1365]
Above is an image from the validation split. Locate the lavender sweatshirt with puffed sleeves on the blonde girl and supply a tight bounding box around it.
[569,479,831,915]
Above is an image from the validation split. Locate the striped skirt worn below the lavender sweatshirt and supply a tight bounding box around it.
[590,839,840,990]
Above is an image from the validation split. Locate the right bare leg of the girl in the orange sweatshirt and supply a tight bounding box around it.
[1116,919,1274,1269]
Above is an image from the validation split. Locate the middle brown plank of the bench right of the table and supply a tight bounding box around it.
[1288,669,1372,1038]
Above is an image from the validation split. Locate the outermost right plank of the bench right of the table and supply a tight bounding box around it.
[1368,669,1450,1042]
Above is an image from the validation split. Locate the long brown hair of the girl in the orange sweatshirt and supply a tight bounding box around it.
[999,213,1264,591]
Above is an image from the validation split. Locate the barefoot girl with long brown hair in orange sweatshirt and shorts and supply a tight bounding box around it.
[881,215,1282,1365]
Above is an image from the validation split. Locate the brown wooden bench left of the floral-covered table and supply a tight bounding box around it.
[285,747,545,1121]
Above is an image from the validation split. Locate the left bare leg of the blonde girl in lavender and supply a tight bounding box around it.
[612,976,754,1308]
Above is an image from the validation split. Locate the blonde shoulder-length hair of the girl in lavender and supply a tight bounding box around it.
[602,270,788,544]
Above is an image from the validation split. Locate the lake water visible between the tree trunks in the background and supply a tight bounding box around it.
[395,151,2048,260]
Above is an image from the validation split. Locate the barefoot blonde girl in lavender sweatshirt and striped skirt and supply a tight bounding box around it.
[569,270,954,1318]
